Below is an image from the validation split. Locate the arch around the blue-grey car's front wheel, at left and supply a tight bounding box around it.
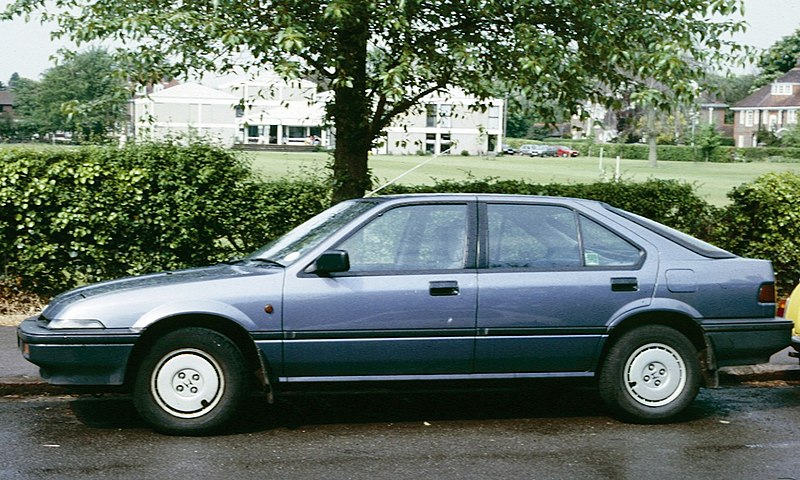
[125,314,271,399]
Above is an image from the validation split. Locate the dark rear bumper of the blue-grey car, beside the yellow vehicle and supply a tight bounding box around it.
[703,318,792,367]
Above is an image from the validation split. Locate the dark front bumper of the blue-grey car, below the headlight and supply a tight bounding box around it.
[17,318,139,385]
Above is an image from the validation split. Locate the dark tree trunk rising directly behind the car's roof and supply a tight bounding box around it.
[329,0,372,203]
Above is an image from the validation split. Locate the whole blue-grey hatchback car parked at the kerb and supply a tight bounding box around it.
[18,195,792,434]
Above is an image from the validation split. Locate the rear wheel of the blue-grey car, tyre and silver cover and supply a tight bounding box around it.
[598,325,700,423]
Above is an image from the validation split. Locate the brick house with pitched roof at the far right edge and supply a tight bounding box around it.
[731,62,800,147]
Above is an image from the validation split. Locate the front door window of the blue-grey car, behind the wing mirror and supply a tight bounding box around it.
[337,204,467,273]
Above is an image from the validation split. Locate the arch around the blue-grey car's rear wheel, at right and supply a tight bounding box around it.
[596,311,718,387]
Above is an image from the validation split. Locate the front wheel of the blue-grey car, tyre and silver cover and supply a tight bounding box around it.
[133,328,247,435]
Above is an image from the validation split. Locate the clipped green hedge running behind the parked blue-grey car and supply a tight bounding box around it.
[0,144,800,294]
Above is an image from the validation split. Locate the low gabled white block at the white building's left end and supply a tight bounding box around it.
[131,83,239,146]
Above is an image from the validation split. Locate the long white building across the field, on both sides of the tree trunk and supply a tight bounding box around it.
[132,75,505,155]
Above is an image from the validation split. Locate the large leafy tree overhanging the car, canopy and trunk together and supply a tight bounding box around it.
[5,0,744,200]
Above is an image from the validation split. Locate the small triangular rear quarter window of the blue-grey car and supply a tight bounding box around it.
[580,216,644,267]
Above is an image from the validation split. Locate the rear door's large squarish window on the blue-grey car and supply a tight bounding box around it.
[487,204,581,270]
